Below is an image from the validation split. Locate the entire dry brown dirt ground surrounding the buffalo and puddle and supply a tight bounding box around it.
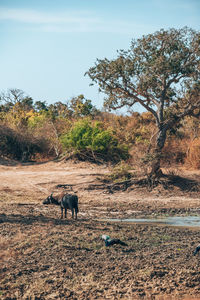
[0,160,200,300]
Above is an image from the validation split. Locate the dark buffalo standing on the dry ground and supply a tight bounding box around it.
[43,194,78,219]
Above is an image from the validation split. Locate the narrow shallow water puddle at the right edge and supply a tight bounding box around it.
[106,216,200,227]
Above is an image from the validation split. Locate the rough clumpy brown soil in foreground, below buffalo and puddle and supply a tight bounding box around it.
[0,204,200,299]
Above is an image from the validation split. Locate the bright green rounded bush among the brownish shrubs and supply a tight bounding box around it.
[61,119,129,162]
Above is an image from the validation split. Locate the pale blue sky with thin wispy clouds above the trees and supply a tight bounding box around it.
[0,0,200,112]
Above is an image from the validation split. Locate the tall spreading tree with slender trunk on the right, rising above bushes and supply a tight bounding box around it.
[86,27,200,176]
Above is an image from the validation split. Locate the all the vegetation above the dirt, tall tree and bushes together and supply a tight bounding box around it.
[0,27,200,176]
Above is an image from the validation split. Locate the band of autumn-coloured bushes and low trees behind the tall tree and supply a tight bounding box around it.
[0,89,200,168]
